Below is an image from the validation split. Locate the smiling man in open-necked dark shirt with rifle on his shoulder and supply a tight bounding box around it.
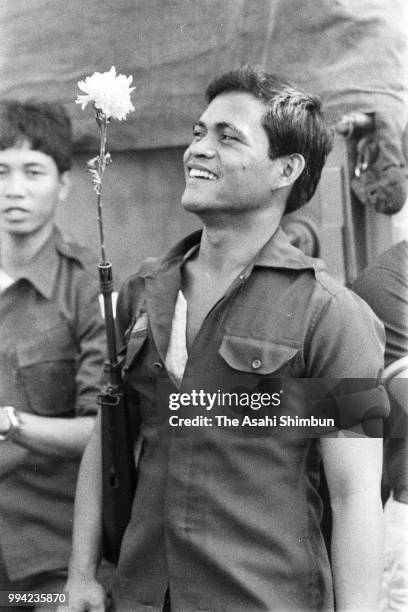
[68,67,387,612]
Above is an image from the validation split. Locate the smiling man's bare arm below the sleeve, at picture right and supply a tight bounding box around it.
[321,436,384,612]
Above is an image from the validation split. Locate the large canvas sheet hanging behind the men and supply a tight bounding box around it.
[0,0,408,273]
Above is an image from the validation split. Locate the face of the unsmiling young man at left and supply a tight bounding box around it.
[0,141,66,235]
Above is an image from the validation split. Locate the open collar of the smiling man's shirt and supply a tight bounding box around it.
[142,227,325,275]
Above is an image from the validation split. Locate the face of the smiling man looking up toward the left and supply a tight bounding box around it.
[182,92,280,214]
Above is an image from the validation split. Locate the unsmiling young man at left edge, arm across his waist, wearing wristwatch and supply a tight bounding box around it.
[0,101,104,609]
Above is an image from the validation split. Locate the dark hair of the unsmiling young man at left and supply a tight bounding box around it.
[0,100,72,174]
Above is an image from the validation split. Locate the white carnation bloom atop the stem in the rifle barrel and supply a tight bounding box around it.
[75,66,135,121]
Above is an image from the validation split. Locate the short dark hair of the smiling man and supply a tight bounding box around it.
[206,66,332,214]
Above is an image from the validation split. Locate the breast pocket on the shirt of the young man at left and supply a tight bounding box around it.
[17,325,77,417]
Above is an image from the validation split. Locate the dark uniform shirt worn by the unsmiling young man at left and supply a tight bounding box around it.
[0,229,105,580]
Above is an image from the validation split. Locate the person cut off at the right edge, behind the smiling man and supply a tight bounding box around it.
[353,240,408,612]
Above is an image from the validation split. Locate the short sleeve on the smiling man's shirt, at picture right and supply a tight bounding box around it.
[306,289,389,436]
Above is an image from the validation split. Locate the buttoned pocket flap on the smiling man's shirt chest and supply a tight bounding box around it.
[218,335,299,374]
